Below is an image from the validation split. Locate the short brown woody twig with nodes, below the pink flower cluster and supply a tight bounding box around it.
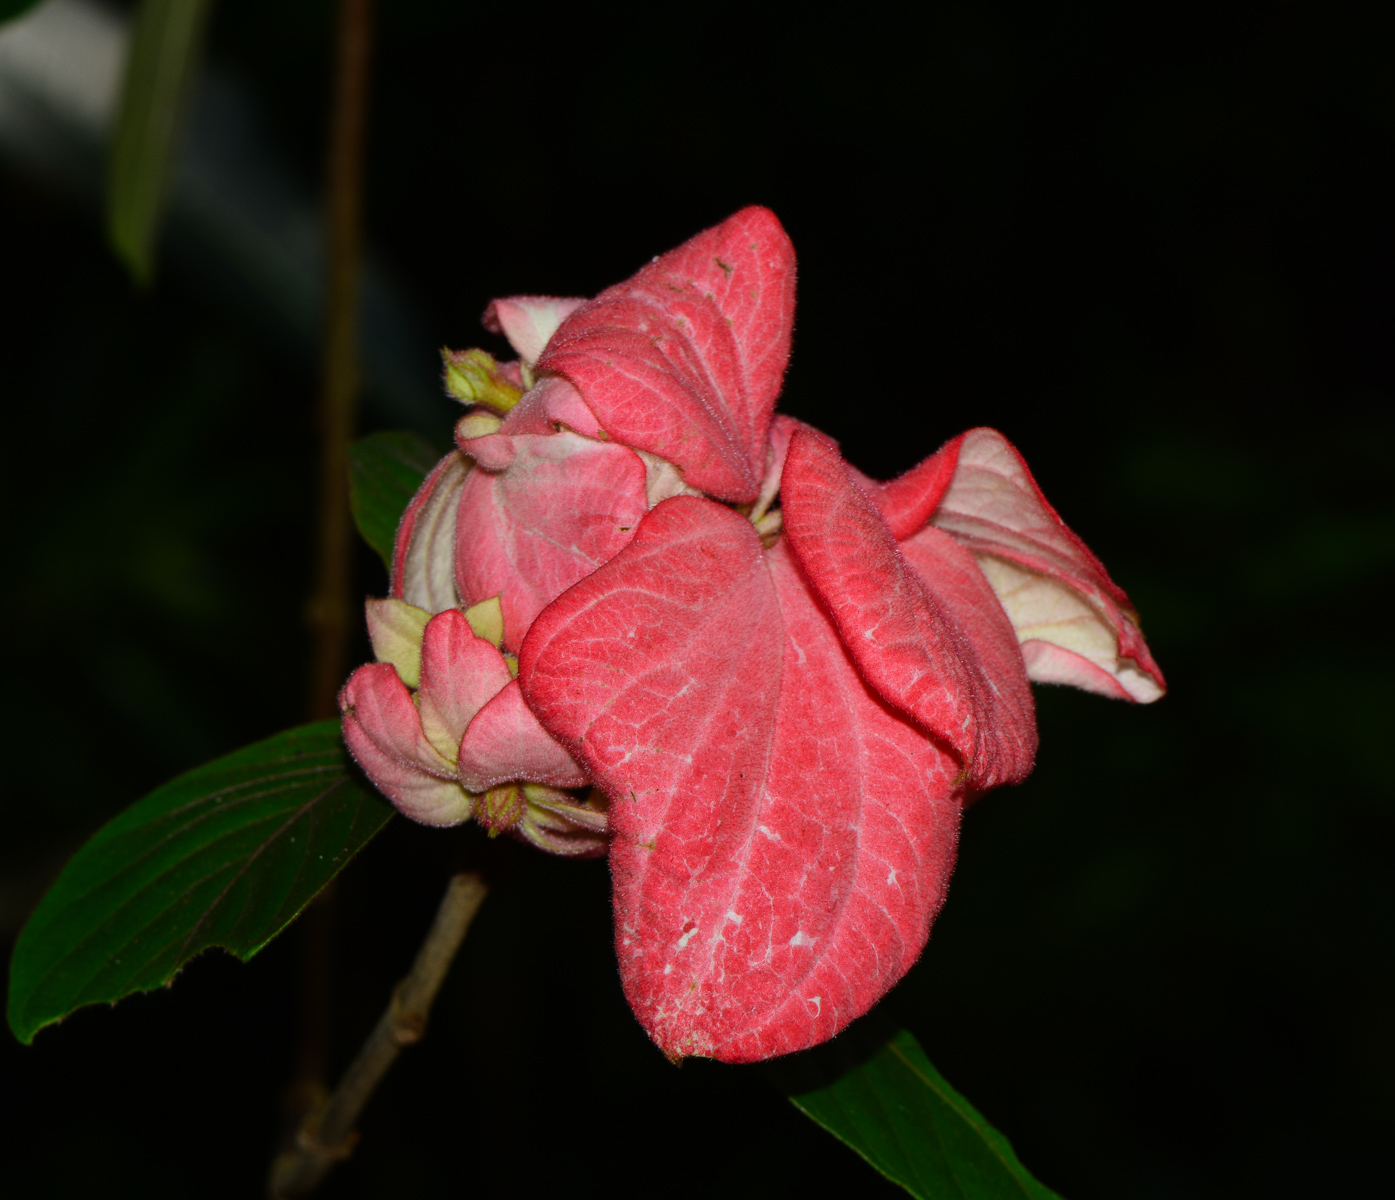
[271,873,485,1200]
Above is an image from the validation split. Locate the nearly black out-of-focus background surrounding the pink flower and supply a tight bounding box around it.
[0,0,1395,1200]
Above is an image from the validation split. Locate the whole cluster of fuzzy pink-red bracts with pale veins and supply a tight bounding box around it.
[342,208,1165,1062]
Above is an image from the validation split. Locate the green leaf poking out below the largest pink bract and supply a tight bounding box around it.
[770,1016,1060,1200]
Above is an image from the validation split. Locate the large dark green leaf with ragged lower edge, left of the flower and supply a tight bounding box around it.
[10,721,392,1042]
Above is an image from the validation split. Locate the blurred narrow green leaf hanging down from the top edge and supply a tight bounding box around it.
[106,0,209,283]
